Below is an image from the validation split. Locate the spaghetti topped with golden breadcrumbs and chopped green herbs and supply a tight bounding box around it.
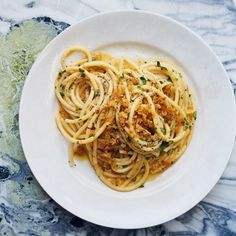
[55,47,197,191]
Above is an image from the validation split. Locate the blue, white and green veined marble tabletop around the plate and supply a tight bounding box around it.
[0,0,236,236]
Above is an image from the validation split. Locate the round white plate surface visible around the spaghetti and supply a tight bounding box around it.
[20,11,235,228]
